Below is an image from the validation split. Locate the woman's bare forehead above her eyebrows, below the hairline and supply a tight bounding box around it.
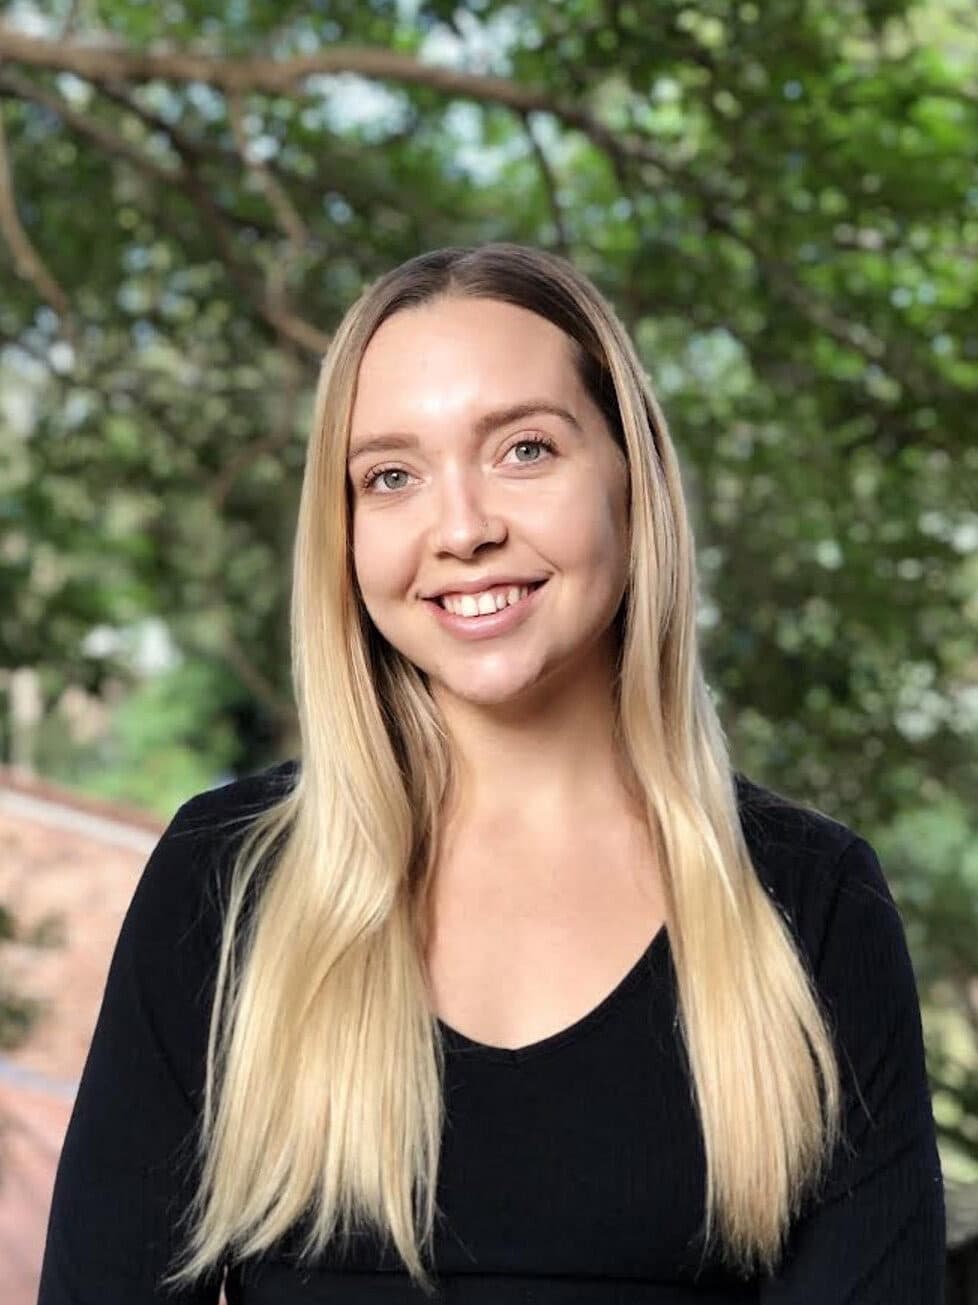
[353,298,580,431]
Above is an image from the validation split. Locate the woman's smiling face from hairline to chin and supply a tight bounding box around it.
[349,299,628,706]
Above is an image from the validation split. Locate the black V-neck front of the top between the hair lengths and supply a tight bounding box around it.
[227,946,757,1305]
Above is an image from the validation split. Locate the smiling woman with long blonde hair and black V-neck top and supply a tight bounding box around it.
[40,244,944,1305]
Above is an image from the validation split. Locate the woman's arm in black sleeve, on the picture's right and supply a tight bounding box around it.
[760,837,945,1305]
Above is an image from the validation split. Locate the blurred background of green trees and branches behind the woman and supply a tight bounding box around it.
[0,0,978,1305]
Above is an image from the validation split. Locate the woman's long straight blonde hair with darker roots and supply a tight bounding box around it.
[170,243,840,1292]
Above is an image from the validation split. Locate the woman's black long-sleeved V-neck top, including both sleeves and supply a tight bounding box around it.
[39,762,944,1305]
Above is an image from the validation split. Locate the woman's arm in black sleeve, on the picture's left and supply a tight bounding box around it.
[38,800,227,1305]
